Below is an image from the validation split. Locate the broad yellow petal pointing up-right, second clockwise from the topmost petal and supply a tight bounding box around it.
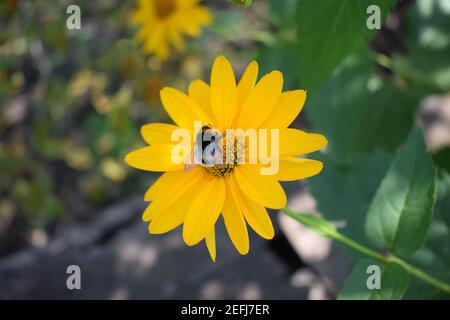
[237,71,283,129]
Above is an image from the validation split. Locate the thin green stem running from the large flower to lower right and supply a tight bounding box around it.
[282,208,450,293]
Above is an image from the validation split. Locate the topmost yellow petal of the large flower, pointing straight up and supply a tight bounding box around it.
[211,56,237,129]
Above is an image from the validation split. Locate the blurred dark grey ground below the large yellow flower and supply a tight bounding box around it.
[0,192,344,299]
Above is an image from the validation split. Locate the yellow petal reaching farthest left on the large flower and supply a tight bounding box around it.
[125,144,184,171]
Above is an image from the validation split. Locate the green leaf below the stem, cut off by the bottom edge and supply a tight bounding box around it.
[338,259,408,300]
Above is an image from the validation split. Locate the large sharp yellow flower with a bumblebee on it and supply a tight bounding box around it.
[125,56,327,260]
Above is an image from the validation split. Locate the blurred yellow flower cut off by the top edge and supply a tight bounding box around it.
[131,0,212,60]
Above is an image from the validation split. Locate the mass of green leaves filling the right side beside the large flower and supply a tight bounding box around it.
[259,0,450,299]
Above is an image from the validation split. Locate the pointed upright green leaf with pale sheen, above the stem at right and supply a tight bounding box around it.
[366,128,436,255]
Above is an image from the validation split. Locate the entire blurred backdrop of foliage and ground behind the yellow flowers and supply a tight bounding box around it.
[0,0,450,299]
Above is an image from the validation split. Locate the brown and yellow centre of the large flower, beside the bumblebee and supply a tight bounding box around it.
[204,132,245,177]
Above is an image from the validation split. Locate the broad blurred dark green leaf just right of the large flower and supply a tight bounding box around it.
[305,55,419,161]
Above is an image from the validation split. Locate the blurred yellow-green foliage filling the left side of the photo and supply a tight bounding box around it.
[0,0,158,230]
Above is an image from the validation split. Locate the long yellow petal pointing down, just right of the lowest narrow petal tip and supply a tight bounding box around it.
[222,181,250,254]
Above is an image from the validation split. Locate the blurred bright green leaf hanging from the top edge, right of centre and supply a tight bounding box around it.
[297,0,395,90]
